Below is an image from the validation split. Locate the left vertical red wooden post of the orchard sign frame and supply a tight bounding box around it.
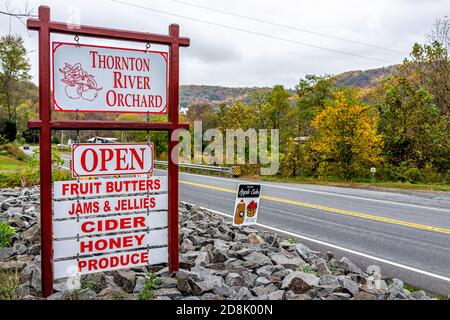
[39,6,53,297]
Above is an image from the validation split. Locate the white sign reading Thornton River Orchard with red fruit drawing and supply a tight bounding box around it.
[52,42,168,114]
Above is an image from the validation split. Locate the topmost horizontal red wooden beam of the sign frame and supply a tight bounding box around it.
[27,19,190,47]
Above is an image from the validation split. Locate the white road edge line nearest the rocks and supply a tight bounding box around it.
[180,201,450,283]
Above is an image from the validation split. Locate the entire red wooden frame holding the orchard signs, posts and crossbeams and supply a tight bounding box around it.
[27,6,190,297]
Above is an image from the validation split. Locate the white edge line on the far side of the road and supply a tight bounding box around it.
[172,169,450,213]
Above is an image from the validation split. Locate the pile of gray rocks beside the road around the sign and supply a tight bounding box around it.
[0,188,435,300]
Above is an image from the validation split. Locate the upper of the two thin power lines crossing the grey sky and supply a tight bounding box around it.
[169,0,408,54]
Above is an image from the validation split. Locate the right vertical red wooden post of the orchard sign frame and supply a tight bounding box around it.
[167,24,180,272]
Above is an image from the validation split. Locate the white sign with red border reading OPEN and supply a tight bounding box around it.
[72,143,154,177]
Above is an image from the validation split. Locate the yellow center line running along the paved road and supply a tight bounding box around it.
[180,180,450,234]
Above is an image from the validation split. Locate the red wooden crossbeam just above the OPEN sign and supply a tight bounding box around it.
[28,120,189,131]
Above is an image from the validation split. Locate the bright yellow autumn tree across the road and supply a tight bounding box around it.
[308,92,382,179]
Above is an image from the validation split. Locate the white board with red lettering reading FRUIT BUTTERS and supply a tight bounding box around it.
[53,176,167,199]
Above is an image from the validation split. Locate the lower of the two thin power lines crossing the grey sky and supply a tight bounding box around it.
[110,0,391,64]
